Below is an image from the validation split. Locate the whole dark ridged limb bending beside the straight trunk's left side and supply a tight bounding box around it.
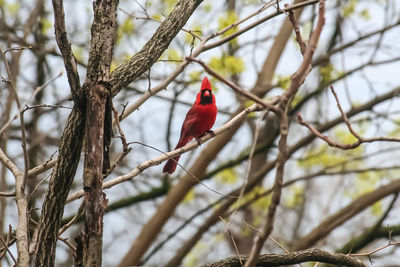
[30,0,85,266]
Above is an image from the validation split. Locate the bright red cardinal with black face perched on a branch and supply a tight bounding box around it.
[163,77,217,174]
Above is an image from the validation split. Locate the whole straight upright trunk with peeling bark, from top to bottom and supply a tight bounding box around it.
[75,0,118,266]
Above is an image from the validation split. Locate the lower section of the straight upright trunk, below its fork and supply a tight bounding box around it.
[76,84,109,266]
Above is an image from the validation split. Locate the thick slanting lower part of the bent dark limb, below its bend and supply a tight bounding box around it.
[35,108,85,266]
